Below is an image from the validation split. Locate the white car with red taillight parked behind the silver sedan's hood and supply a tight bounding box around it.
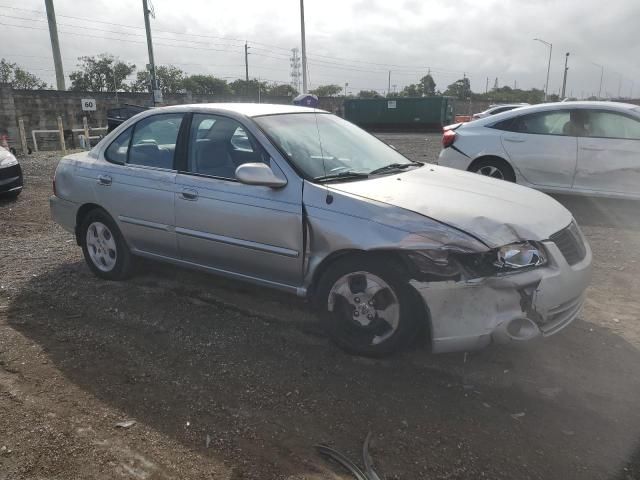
[438,102,640,200]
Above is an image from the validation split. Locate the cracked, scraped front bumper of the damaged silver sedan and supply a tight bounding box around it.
[411,238,592,353]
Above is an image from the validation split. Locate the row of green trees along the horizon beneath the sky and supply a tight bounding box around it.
[0,53,558,103]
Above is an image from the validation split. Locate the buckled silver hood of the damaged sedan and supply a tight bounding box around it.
[330,164,572,247]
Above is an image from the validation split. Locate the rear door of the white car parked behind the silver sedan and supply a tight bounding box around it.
[494,110,578,189]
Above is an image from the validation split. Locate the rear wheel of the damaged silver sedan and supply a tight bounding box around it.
[80,210,132,280]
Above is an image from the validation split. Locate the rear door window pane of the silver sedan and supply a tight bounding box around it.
[128,113,183,169]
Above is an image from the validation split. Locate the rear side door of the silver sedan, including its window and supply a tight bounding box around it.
[96,113,184,258]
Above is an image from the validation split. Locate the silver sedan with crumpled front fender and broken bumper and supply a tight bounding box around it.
[51,104,591,356]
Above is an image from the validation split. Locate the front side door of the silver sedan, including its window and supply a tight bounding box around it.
[175,113,303,286]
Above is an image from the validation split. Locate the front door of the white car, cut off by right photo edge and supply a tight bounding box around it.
[575,110,640,196]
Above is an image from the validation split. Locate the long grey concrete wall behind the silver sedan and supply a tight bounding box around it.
[0,84,342,151]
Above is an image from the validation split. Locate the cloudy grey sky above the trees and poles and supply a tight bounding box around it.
[0,0,640,98]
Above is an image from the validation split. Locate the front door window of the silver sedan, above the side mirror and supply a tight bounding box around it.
[187,113,269,180]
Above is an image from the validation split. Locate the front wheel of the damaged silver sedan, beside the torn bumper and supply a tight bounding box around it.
[315,256,425,357]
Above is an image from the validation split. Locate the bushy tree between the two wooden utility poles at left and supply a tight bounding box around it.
[69,53,136,92]
